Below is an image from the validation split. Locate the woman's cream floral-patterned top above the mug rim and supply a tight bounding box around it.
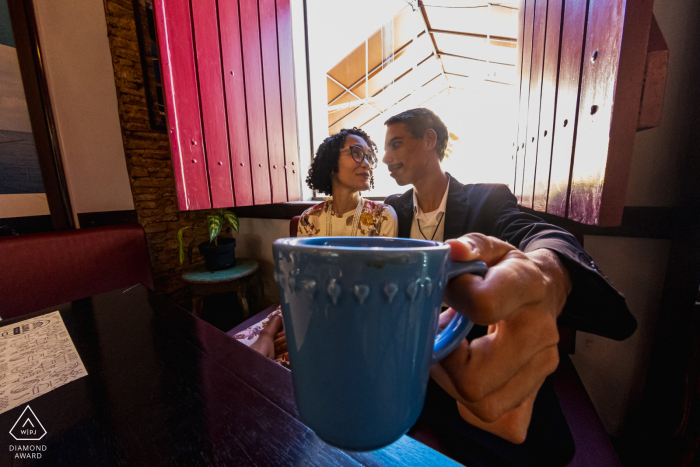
[297,199,399,237]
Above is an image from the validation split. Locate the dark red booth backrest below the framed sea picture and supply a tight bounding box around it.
[0,225,154,319]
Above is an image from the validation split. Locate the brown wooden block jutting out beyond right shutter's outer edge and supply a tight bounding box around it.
[637,16,668,131]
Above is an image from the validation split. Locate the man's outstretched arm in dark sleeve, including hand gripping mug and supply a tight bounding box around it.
[431,185,636,443]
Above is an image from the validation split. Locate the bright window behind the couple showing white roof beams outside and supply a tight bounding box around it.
[295,0,519,198]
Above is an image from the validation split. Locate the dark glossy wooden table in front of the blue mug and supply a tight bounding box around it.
[0,285,458,467]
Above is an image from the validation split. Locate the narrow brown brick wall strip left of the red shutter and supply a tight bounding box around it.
[104,0,196,304]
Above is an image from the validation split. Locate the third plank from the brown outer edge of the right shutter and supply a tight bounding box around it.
[532,0,563,212]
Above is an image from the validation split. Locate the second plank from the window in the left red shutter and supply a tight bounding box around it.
[259,0,287,203]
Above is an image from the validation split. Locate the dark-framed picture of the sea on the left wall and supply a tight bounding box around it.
[0,0,75,230]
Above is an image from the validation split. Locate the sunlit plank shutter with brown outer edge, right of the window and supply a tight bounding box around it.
[513,0,652,226]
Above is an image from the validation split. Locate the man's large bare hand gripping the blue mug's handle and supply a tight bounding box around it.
[430,234,571,443]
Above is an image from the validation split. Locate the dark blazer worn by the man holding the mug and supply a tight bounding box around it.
[384,176,637,340]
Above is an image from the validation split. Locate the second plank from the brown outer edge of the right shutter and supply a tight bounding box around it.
[547,0,587,217]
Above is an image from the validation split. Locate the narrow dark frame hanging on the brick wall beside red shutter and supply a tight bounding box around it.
[134,0,167,131]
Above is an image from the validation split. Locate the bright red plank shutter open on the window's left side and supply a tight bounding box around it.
[154,0,301,210]
